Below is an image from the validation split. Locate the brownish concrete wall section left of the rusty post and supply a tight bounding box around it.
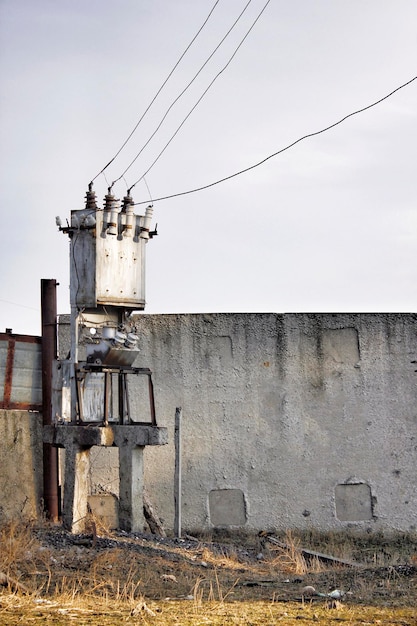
[0,410,43,522]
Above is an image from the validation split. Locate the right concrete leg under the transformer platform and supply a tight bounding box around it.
[119,445,145,532]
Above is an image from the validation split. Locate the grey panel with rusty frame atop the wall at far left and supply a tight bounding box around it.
[0,333,42,411]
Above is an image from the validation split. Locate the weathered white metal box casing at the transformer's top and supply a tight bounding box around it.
[70,208,148,310]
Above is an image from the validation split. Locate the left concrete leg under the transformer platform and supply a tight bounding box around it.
[62,443,91,534]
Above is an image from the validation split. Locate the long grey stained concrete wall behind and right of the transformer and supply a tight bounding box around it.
[61,314,417,530]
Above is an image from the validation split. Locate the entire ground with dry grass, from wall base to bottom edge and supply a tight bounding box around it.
[0,522,417,626]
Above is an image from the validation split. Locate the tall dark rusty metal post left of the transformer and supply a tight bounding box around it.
[41,278,59,522]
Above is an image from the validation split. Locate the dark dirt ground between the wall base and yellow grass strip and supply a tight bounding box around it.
[0,524,417,624]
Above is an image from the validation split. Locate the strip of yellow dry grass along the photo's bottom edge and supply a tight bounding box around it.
[0,596,417,626]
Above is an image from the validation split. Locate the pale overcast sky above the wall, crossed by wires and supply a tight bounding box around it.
[0,0,417,334]
